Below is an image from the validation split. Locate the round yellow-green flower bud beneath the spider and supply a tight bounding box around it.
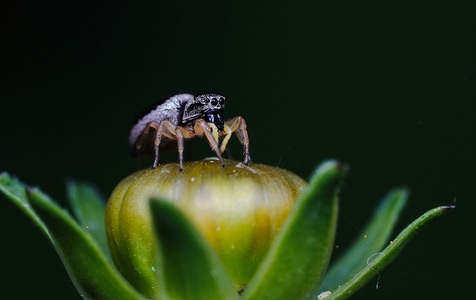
[106,159,307,297]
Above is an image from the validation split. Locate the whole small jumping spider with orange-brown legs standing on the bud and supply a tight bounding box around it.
[129,94,251,171]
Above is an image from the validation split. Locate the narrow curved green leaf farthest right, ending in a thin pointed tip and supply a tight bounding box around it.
[325,206,454,300]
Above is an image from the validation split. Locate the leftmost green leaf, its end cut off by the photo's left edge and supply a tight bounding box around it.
[0,173,51,241]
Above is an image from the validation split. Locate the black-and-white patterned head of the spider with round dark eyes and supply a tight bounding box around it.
[182,94,225,131]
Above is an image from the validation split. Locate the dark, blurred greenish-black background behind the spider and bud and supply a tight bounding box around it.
[0,0,476,299]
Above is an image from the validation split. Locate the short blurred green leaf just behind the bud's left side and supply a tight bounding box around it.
[67,181,112,261]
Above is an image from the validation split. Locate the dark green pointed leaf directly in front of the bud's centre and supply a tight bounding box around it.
[150,200,238,300]
